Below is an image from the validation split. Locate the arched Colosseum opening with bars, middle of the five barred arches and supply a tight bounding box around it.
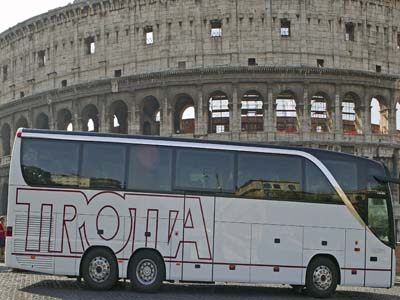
[275,92,299,133]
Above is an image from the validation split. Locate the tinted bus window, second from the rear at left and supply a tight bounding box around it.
[80,143,126,189]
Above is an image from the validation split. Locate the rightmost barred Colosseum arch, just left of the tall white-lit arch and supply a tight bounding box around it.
[342,93,361,134]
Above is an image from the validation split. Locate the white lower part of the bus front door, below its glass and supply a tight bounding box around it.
[365,230,392,288]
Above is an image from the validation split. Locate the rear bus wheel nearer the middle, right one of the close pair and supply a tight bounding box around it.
[129,250,165,292]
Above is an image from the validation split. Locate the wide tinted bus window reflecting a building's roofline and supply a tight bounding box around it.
[235,153,302,201]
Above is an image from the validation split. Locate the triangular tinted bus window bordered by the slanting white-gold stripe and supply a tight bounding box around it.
[304,160,343,204]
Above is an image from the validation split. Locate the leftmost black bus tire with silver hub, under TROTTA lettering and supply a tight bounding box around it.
[81,248,118,290]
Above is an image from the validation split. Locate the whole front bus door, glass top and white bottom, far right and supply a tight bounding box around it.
[365,193,392,287]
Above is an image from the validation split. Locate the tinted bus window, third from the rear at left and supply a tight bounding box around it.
[127,145,172,191]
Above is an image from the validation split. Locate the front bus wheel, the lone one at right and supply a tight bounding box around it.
[306,256,339,298]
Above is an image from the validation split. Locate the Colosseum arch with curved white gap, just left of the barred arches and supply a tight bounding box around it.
[174,95,195,134]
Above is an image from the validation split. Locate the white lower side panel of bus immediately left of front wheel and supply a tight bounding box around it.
[250,224,303,284]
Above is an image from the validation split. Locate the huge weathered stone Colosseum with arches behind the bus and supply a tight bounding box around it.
[0,0,400,237]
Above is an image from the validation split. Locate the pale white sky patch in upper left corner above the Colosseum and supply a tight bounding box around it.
[0,0,73,32]
